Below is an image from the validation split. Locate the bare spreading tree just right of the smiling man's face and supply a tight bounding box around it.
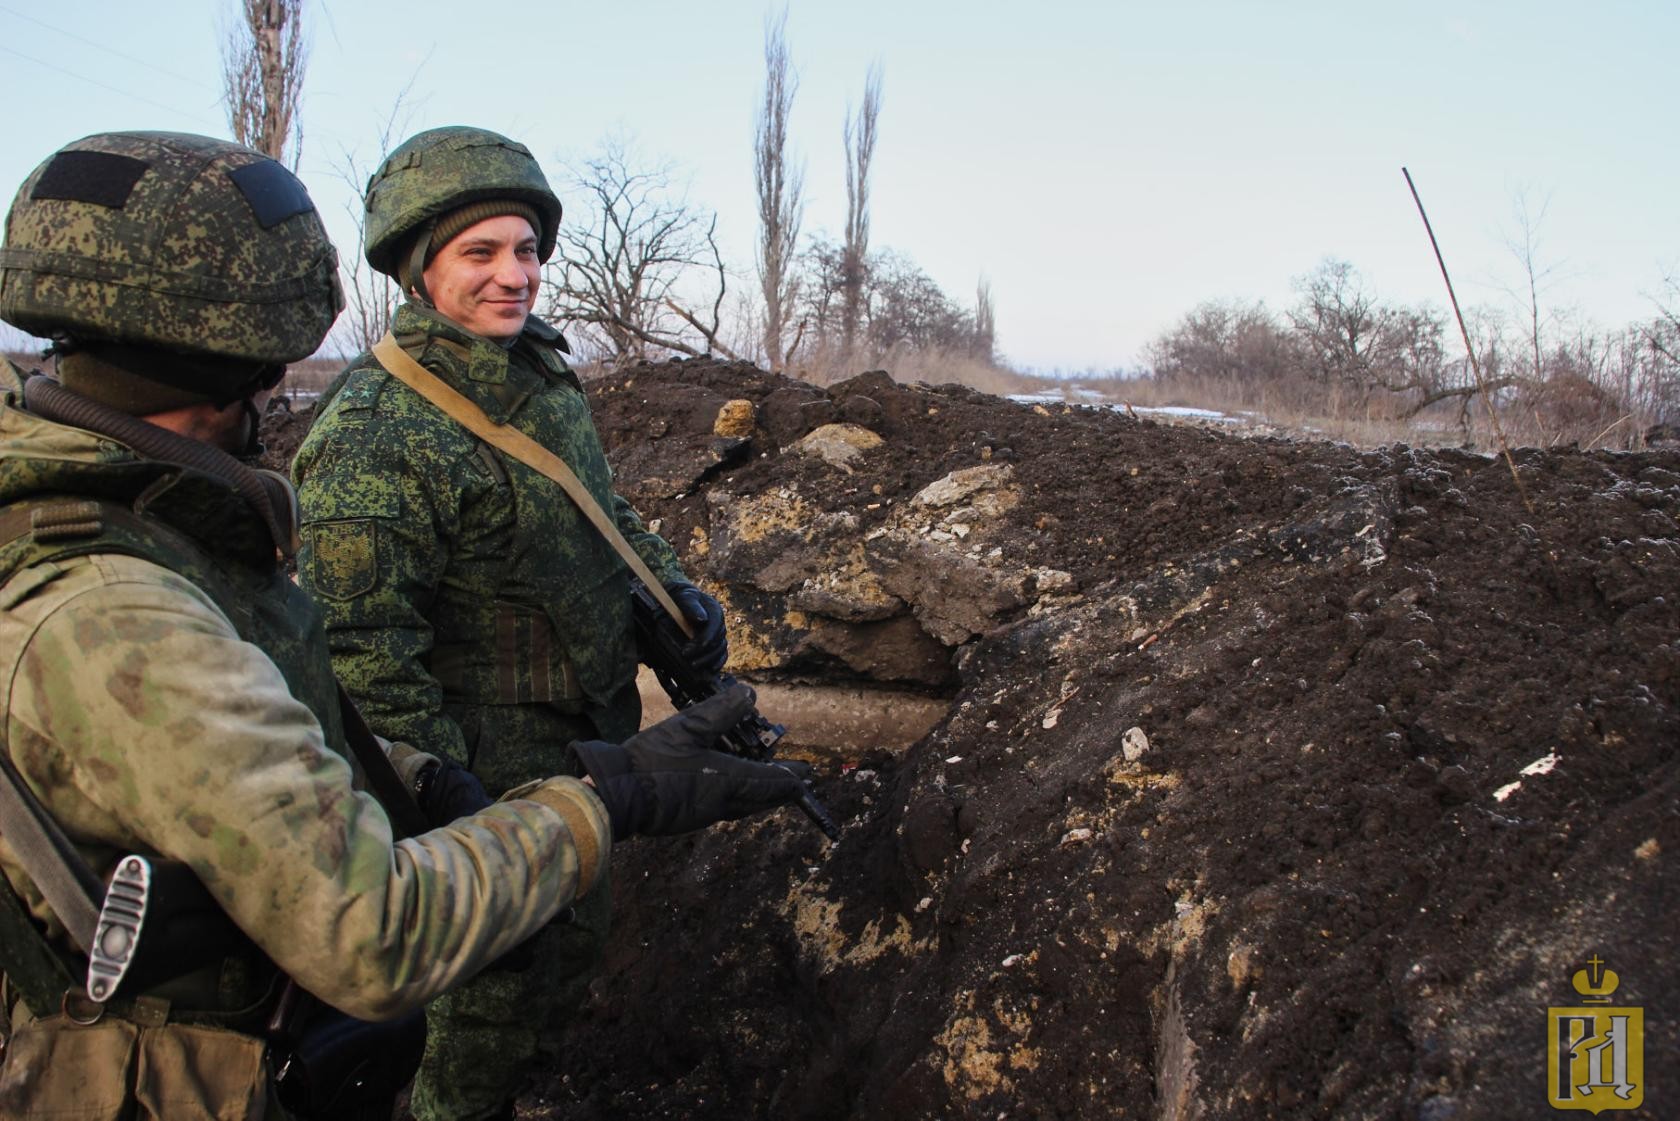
[546,138,736,363]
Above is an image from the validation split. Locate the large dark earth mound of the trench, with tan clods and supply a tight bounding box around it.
[270,360,1680,1121]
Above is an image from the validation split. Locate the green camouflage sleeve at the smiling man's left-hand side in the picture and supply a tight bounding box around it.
[294,385,480,763]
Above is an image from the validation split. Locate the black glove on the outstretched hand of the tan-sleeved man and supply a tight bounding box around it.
[571,684,811,840]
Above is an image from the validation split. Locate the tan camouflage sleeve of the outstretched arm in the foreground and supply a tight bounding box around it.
[7,556,610,1018]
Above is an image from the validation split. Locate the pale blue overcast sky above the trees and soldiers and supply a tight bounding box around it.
[0,0,1680,371]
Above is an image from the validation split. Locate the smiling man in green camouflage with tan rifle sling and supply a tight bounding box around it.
[292,128,726,1121]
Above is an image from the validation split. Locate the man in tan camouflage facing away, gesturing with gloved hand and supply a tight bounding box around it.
[0,133,813,1121]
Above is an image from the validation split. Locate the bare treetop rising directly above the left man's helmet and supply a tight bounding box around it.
[222,0,309,171]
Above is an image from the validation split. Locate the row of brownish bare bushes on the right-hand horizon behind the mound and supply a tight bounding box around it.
[1146,261,1680,447]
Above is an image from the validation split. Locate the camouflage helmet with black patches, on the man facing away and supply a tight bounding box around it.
[0,133,344,365]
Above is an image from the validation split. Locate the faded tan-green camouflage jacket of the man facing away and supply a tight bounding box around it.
[0,361,610,1028]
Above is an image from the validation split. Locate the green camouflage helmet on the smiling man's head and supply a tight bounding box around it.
[363,126,559,279]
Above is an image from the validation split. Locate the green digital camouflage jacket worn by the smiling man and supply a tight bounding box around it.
[292,303,682,793]
